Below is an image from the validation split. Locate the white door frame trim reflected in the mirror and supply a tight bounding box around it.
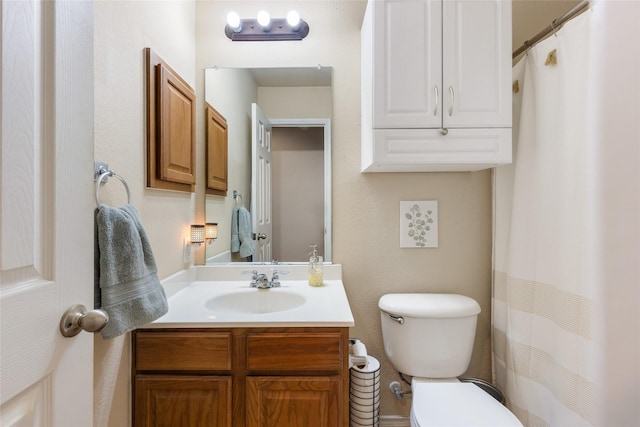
[269,118,333,262]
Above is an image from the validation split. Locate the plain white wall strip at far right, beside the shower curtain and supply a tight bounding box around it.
[590,1,640,426]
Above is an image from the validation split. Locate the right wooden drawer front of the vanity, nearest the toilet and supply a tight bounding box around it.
[247,332,346,371]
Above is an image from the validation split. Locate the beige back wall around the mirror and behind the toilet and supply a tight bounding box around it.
[197,1,491,415]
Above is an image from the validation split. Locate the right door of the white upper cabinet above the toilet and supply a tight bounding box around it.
[442,0,511,128]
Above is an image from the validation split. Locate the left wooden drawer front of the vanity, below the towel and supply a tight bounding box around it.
[134,332,231,371]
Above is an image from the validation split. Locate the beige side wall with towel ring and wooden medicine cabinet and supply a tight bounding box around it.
[94,1,196,427]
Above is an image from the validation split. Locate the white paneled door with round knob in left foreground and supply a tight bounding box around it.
[0,0,94,427]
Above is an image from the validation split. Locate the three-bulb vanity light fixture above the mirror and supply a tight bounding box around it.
[224,10,309,41]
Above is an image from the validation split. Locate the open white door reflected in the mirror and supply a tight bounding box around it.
[251,103,273,262]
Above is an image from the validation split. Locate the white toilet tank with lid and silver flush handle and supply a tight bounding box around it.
[378,293,480,378]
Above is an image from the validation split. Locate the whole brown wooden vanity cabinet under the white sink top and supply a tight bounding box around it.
[132,328,349,427]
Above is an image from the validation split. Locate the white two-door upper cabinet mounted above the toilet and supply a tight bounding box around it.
[362,0,511,172]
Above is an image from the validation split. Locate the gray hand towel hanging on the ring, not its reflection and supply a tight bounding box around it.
[95,204,169,339]
